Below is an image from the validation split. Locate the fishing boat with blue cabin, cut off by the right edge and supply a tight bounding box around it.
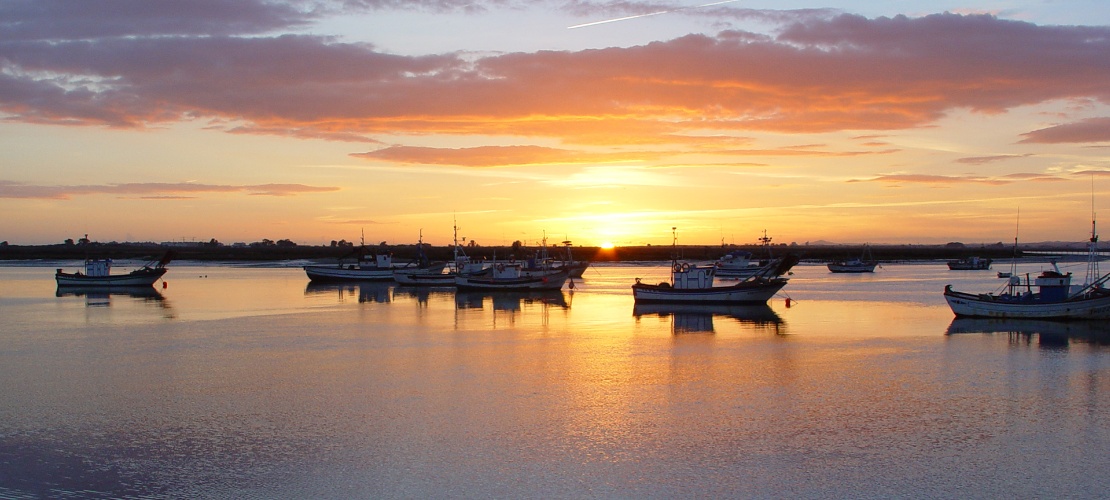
[945,221,1110,320]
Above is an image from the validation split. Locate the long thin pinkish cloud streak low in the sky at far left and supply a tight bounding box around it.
[0,180,340,200]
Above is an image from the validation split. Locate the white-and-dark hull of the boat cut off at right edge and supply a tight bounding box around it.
[945,290,1110,320]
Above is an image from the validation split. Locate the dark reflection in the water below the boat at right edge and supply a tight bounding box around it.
[947,318,1110,349]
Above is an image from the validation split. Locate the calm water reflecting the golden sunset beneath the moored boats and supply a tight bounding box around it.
[0,262,1110,499]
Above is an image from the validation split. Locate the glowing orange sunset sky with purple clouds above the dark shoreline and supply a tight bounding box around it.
[0,0,1110,246]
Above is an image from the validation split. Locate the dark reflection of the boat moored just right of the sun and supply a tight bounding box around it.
[632,303,786,334]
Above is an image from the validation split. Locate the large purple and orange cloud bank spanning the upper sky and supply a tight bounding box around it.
[0,8,1110,146]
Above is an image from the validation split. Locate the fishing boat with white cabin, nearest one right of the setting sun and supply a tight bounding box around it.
[632,227,798,304]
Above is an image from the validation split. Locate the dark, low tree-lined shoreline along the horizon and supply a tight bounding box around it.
[0,242,1086,262]
